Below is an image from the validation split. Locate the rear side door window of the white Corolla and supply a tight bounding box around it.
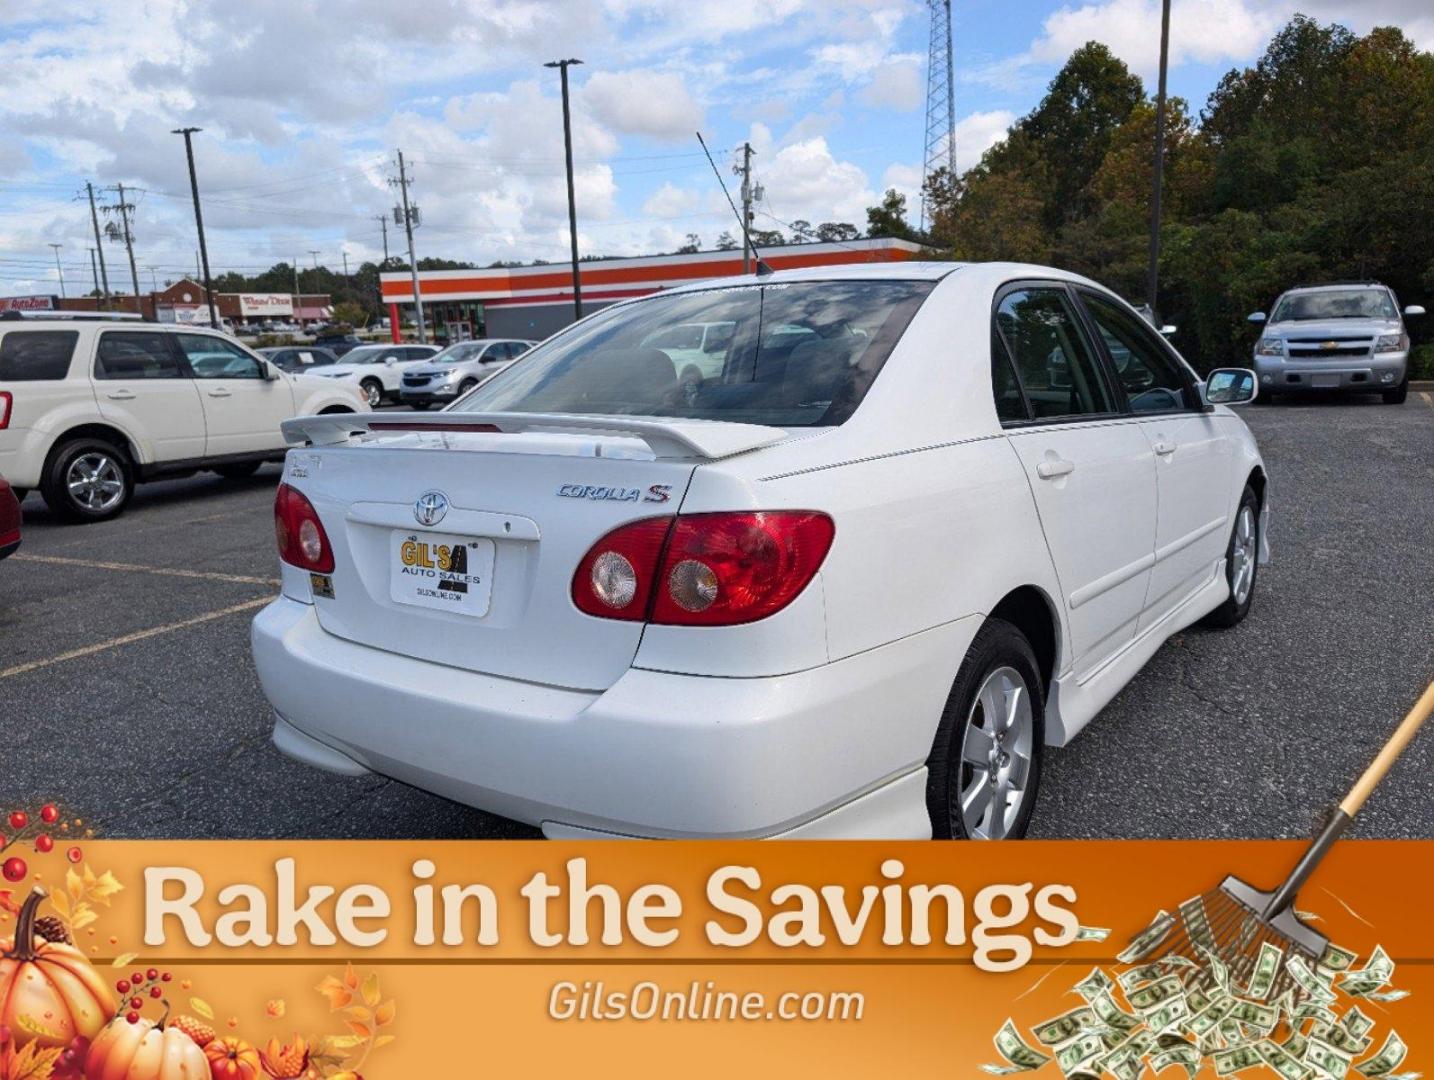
[995,285,1114,420]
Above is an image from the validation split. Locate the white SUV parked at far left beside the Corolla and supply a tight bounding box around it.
[0,318,367,522]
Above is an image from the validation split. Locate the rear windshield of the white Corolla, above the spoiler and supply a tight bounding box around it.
[459,281,934,427]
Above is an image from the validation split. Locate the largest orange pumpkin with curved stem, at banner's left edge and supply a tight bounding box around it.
[0,886,115,1047]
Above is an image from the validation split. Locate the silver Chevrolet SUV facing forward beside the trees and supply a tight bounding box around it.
[1249,281,1424,404]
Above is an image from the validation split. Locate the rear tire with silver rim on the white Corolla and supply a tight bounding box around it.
[926,618,1045,840]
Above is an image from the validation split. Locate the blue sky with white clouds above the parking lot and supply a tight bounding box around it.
[0,0,1434,295]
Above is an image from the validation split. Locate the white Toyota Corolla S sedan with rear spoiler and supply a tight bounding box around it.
[252,262,1268,838]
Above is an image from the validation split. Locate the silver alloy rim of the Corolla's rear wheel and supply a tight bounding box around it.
[959,667,1035,840]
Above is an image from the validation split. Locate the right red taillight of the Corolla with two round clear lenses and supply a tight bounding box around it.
[572,511,836,627]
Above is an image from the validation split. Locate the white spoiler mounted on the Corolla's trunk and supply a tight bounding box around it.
[280,412,787,459]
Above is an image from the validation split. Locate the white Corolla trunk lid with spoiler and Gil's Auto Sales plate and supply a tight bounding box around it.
[284,413,784,690]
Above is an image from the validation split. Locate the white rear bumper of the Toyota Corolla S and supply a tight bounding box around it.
[252,598,979,839]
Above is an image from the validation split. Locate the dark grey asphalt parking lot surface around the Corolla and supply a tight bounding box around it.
[0,392,1434,839]
